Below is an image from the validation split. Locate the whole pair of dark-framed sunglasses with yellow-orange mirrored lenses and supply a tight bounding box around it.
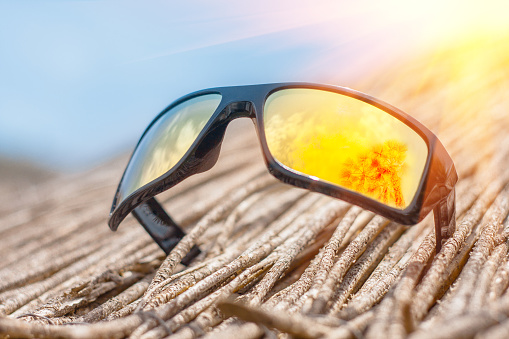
[108,83,458,265]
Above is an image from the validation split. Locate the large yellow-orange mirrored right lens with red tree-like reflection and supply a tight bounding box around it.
[263,89,428,209]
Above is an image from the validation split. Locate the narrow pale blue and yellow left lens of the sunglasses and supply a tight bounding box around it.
[117,94,221,205]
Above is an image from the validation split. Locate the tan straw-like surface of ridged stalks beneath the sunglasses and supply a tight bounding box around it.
[0,37,509,339]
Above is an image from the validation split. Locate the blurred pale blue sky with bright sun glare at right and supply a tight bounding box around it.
[0,0,509,171]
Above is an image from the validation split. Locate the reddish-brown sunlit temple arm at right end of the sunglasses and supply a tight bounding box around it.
[433,188,456,254]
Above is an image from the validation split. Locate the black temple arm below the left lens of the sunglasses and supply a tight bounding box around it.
[132,198,201,266]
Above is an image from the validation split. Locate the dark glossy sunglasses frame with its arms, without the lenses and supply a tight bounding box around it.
[108,83,458,264]
